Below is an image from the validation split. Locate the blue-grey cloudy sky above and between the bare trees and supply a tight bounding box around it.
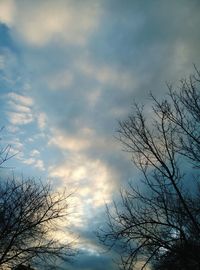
[0,0,200,270]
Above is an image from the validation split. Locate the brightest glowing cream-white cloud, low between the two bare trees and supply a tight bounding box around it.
[49,154,116,227]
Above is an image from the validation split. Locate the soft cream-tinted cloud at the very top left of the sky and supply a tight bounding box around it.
[0,0,101,46]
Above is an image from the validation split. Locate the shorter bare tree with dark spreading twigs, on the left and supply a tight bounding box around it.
[0,138,75,269]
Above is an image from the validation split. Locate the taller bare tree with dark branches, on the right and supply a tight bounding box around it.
[99,70,200,269]
